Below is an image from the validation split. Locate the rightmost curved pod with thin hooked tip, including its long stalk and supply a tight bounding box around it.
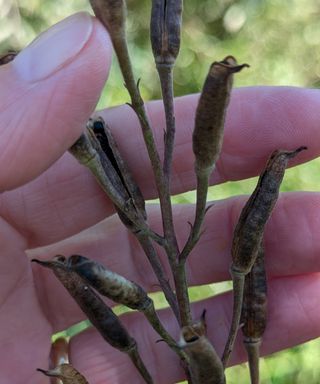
[222,147,306,366]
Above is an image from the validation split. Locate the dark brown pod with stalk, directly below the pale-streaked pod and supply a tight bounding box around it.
[32,255,153,383]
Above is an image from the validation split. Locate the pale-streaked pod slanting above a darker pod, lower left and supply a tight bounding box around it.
[68,255,151,310]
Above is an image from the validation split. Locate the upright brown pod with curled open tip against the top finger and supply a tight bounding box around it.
[192,56,248,174]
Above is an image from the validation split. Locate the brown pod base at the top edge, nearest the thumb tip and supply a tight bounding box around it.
[90,0,126,38]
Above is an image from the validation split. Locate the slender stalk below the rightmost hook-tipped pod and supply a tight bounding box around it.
[221,269,245,368]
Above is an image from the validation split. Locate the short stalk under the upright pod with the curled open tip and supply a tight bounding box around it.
[180,170,211,263]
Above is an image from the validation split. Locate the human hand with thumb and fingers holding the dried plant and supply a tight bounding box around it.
[0,14,320,384]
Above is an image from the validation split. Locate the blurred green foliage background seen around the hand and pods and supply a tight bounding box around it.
[0,0,320,384]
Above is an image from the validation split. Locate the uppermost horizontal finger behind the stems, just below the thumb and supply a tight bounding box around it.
[0,87,320,246]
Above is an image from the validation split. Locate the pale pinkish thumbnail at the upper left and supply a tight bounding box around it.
[12,12,92,83]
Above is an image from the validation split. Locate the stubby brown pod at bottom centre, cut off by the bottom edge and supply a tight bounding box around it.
[180,315,226,384]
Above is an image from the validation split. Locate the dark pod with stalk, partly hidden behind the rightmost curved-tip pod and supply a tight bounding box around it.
[241,245,267,384]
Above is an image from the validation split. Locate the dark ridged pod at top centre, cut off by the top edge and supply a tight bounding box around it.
[150,0,182,65]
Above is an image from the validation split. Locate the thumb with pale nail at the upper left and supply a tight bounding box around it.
[0,13,111,192]
